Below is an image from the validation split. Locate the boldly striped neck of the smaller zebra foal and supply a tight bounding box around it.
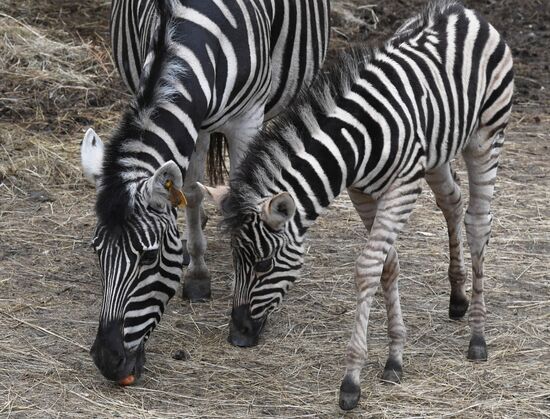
[256,104,370,234]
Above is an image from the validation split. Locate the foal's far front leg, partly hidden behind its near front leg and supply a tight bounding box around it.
[348,189,407,383]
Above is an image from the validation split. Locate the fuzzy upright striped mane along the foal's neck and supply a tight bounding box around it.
[222,48,372,236]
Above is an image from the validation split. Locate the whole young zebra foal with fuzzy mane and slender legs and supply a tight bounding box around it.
[207,1,513,409]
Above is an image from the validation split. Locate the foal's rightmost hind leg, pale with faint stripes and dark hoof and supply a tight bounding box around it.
[462,129,504,361]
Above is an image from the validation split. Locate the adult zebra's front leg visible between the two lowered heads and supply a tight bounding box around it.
[182,132,211,301]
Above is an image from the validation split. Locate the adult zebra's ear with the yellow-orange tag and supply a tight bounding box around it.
[146,160,187,210]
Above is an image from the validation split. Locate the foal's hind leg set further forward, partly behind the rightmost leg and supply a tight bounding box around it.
[426,163,468,320]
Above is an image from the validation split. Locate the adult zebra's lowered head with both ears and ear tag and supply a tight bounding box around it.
[82,131,185,381]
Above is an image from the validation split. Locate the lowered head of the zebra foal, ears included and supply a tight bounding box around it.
[204,187,304,346]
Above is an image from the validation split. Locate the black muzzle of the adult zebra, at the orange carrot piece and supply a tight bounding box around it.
[90,321,145,383]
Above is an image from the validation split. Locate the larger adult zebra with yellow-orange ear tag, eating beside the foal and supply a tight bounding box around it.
[82,0,329,383]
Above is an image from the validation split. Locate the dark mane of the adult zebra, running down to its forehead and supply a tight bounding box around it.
[96,0,186,229]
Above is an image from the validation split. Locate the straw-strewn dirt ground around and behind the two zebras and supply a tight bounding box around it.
[0,0,550,418]
